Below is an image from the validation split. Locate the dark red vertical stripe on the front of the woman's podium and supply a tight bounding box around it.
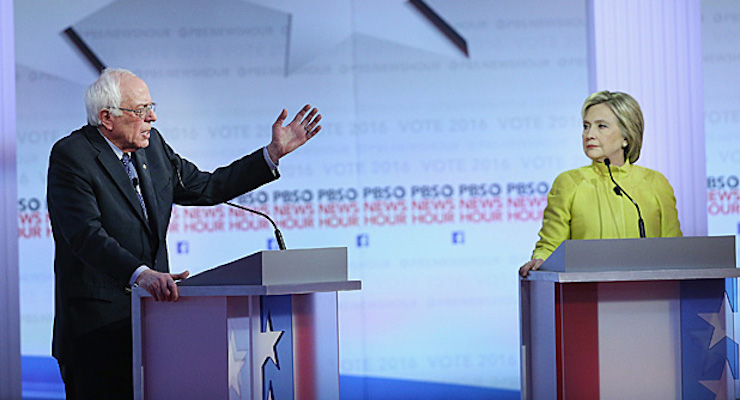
[555,283,599,400]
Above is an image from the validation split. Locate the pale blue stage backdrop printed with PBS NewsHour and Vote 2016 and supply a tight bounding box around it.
[15,0,740,398]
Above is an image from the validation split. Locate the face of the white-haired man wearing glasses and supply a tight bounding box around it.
[101,76,157,152]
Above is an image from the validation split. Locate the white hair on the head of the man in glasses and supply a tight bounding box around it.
[85,68,136,126]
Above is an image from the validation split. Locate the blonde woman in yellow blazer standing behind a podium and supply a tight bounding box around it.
[519,91,681,276]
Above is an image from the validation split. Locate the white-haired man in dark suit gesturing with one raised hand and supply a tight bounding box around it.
[47,70,321,399]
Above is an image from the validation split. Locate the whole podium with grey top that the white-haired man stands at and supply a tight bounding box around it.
[132,248,361,400]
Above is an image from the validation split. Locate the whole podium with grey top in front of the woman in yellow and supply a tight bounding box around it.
[520,236,740,400]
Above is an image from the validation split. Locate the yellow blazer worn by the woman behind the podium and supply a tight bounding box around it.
[532,161,682,259]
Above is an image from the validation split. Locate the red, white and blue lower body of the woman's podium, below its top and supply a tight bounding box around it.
[521,278,740,400]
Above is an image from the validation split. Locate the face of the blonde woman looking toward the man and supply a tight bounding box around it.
[583,104,627,166]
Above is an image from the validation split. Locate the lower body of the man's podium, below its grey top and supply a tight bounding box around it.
[132,290,339,400]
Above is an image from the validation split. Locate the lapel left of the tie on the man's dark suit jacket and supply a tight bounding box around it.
[85,127,151,233]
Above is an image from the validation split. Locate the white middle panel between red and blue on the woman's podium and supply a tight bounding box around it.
[590,281,681,400]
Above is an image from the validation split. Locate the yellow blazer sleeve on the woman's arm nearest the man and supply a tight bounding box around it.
[532,173,575,260]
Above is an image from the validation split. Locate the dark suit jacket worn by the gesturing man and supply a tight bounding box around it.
[47,125,277,362]
